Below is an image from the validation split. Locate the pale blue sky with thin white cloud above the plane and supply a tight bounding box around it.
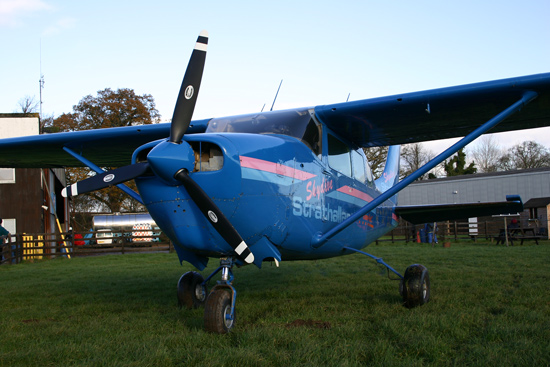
[0,0,550,153]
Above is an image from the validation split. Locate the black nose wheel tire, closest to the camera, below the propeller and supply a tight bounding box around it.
[204,289,236,334]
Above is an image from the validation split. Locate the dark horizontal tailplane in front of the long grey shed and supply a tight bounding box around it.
[395,195,523,224]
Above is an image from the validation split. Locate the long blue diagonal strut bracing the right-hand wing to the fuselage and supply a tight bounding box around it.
[311,91,538,248]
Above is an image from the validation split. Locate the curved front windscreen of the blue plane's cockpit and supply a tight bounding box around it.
[206,109,321,156]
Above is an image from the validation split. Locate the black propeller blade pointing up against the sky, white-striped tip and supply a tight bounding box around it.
[170,31,208,144]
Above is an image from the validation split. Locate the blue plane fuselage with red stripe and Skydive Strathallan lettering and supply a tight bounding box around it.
[134,110,397,268]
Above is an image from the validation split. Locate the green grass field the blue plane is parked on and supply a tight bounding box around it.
[0,241,550,367]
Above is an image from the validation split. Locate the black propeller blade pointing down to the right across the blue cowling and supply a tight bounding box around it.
[174,169,254,264]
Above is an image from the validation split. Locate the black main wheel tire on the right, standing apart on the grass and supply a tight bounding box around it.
[399,264,430,308]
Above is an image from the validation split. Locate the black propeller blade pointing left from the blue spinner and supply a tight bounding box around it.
[61,162,149,197]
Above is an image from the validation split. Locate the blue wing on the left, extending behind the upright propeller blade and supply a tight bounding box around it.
[0,119,209,168]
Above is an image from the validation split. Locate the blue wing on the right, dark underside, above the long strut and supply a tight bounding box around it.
[315,73,550,147]
